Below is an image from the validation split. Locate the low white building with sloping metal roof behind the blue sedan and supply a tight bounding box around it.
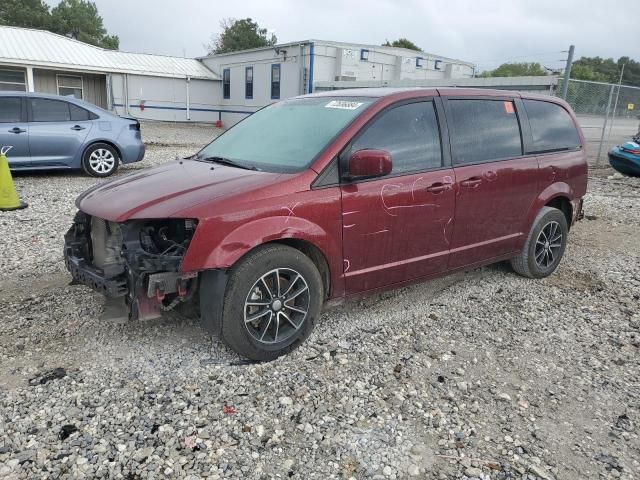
[0,26,220,122]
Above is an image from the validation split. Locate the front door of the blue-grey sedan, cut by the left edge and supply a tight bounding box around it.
[0,96,31,168]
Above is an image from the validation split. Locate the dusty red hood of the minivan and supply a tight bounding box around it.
[76,160,281,222]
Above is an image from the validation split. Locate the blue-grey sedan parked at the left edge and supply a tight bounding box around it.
[0,92,145,177]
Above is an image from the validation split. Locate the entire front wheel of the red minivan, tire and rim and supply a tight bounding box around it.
[220,245,324,361]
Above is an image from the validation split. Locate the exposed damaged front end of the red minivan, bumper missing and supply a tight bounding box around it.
[64,211,198,320]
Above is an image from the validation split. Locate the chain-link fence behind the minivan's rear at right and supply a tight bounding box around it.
[554,79,640,166]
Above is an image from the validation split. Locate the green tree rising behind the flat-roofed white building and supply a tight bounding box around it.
[207,18,278,54]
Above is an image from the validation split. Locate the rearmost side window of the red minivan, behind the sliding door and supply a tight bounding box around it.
[524,100,580,153]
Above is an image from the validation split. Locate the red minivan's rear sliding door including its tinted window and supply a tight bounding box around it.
[445,98,538,269]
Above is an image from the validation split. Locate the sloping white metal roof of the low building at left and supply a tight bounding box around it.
[0,26,220,80]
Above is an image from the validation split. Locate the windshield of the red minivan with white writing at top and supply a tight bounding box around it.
[195,97,376,172]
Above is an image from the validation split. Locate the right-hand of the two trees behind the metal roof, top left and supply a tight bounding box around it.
[51,0,120,50]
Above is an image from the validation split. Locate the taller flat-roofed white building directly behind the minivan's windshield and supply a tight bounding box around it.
[200,40,475,125]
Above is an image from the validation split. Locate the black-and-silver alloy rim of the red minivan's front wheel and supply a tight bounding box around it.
[244,268,311,344]
